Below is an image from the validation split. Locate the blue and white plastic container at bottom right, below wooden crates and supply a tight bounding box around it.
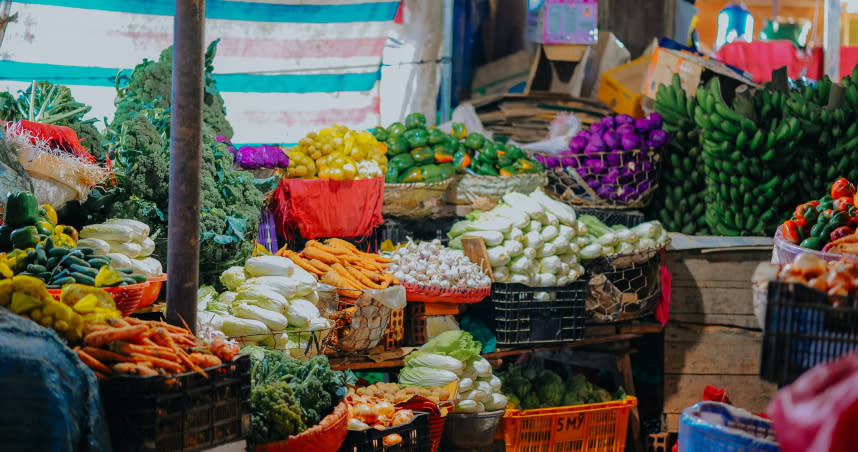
[679,402,779,452]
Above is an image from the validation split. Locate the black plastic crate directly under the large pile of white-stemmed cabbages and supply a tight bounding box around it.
[491,279,587,346]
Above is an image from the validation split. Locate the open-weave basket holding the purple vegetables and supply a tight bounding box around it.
[545,148,663,209]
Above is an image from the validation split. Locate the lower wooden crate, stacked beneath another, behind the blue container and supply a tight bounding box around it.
[664,319,777,432]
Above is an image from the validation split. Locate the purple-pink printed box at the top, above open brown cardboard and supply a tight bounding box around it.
[526,0,599,45]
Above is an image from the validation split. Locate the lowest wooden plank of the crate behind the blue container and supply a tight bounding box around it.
[664,374,777,432]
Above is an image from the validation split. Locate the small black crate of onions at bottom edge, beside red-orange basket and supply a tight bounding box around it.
[340,411,432,452]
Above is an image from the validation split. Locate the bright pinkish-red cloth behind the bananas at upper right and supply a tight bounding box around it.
[716,41,811,83]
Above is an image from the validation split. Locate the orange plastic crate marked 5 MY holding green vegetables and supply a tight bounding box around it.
[495,396,638,452]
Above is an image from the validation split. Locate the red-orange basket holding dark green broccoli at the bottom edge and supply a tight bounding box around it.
[253,400,349,452]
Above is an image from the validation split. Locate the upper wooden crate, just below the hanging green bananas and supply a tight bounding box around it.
[667,249,771,329]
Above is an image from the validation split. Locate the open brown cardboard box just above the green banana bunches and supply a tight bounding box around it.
[643,47,756,102]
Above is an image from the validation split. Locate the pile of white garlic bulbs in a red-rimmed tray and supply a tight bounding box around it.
[388,239,492,289]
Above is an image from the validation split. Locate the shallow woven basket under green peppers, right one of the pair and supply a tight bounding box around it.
[446,173,548,205]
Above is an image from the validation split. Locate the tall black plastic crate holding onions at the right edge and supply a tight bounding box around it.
[760,281,858,385]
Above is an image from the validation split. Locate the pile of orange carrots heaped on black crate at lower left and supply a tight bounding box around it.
[74,317,237,378]
